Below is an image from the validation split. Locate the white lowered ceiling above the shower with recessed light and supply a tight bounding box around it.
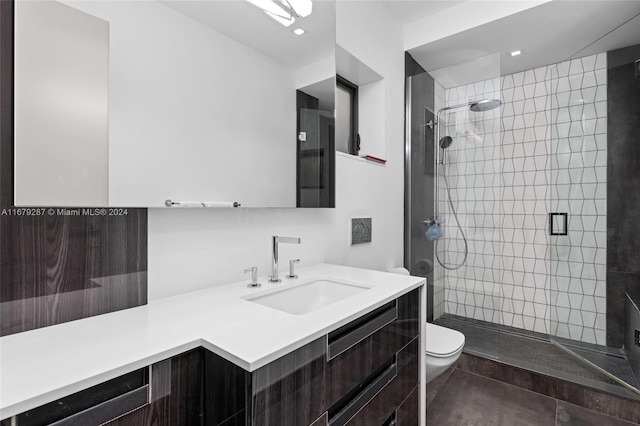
[402,0,640,87]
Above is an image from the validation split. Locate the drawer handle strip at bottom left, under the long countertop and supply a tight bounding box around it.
[51,385,149,426]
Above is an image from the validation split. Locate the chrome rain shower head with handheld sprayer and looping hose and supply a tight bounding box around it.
[424,99,501,270]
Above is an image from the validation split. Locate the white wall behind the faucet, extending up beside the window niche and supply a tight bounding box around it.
[149,1,404,299]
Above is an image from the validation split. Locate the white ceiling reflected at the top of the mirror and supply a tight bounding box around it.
[161,0,336,69]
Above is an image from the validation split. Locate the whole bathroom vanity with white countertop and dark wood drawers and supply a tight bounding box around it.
[0,265,424,426]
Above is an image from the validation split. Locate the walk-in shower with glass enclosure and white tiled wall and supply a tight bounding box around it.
[405,41,640,408]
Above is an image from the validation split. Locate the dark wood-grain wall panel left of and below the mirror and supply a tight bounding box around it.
[0,0,147,335]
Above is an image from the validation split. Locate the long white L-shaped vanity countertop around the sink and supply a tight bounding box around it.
[0,264,425,419]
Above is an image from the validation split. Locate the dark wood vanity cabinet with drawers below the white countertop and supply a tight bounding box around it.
[8,289,420,426]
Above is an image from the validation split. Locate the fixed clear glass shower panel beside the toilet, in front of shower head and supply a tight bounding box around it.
[424,55,504,359]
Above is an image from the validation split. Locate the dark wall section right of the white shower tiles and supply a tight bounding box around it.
[607,45,640,348]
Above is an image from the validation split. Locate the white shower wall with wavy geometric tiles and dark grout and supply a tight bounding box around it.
[434,53,607,345]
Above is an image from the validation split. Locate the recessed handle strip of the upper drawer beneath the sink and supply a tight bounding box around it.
[327,300,398,361]
